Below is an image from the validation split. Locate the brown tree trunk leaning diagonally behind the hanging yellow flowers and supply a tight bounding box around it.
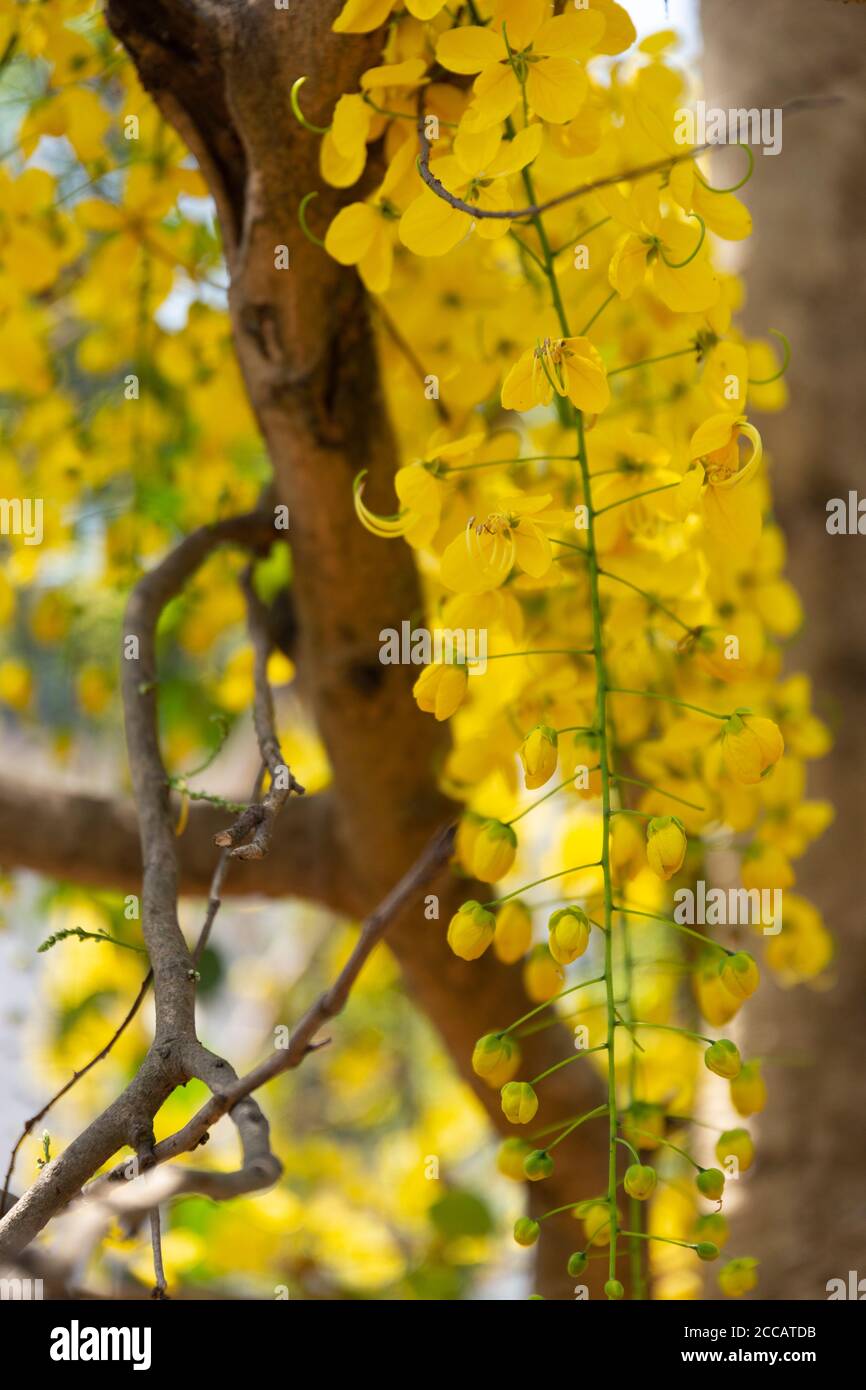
[0,0,606,1298]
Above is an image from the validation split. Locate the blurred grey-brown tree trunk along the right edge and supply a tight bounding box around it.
[702,0,866,1298]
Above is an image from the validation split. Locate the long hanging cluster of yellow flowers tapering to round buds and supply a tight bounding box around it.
[321,0,831,1298]
